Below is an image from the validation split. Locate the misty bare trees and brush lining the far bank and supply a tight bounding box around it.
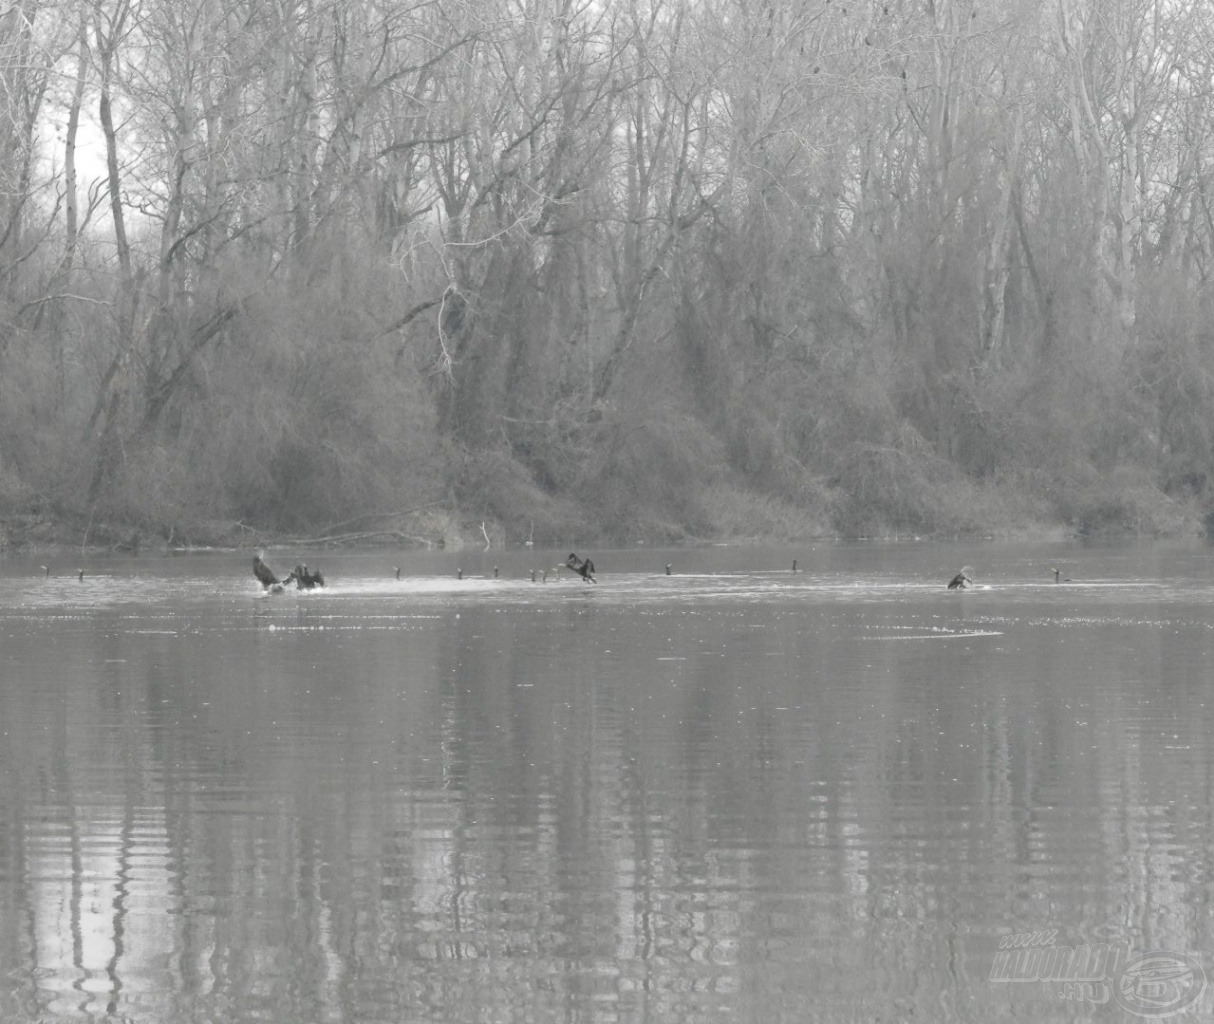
[0,0,1214,542]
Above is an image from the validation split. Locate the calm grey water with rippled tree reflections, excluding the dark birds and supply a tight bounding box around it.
[0,542,1214,1024]
